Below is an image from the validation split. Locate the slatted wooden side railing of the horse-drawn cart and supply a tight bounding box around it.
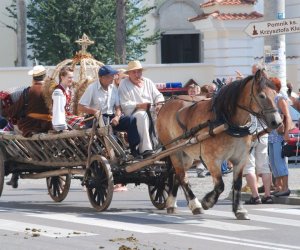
[0,127,109,167]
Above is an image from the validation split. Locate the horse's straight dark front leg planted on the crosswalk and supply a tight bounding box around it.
[232,171,249,220]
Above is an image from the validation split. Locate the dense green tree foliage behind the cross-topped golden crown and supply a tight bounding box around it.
[27,0,159,65]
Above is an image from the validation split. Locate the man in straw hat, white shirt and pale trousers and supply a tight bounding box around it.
[119,61,164,157]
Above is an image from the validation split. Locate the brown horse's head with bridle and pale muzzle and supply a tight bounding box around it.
[249,70,282,129]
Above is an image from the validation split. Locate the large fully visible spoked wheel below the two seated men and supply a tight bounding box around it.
[85,155,114,212]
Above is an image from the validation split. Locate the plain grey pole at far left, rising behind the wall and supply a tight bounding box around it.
[16,0,27,66]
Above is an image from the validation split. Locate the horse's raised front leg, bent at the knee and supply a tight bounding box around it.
[201,162,224,210]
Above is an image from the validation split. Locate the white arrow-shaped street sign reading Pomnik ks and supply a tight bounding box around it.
[244,17,300,37]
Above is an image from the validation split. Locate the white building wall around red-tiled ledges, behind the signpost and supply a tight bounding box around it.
[190,0,300,89]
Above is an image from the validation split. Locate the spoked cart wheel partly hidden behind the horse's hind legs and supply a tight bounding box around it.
[148,162,174,210]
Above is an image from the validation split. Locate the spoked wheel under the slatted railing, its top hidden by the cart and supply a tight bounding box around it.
[46,174,72,202]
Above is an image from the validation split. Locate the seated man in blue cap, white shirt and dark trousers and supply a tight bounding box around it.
[78,65,140,156]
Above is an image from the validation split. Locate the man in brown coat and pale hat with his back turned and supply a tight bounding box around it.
[3,65,52,188]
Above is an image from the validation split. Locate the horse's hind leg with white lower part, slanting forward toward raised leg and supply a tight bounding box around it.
[181,172,204,215]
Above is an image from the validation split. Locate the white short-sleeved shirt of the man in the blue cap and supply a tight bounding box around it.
[79,79,120,115]
